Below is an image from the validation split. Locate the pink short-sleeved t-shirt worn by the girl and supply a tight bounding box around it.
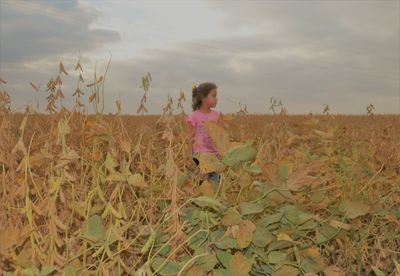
[186,110,219,153]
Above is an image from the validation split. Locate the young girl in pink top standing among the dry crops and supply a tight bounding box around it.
[186,82,220,183]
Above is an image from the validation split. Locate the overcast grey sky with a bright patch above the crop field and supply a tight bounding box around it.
[0,0,400,114]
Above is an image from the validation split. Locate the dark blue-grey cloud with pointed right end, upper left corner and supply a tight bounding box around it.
[0,1,120,63]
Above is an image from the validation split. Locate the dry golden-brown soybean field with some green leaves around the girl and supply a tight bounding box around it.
[0,64,400,276]
